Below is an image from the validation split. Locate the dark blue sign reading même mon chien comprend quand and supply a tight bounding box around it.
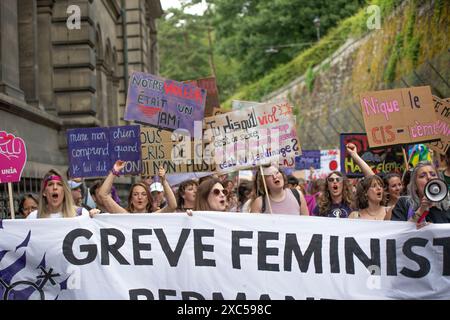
[67,125,142,178]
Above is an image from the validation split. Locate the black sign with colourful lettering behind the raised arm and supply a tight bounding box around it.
[340,133,405,178]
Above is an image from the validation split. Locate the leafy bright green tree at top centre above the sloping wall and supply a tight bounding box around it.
[209,0,365,83]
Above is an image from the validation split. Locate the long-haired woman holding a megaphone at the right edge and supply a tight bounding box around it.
[392,161,450,228]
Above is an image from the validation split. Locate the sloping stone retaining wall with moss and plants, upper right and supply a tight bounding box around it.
[264,1,450,149]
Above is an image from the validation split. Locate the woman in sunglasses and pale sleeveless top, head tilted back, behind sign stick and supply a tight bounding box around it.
[250,165,309,216]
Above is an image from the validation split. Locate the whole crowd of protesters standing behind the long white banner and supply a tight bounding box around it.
[5,143,450,228]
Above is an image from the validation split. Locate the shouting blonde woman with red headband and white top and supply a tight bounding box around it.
[27,169,89,219]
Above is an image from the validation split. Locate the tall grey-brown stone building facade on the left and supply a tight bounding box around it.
[0,0,163,218]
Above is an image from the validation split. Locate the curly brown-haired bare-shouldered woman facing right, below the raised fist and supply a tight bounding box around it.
[349,175,392,220]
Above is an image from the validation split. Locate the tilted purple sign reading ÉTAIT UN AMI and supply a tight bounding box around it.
[124,72,206,136]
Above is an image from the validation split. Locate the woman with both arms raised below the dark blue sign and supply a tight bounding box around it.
[98,160,177,213]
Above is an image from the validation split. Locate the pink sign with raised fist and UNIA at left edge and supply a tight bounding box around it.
[0,131,27,183]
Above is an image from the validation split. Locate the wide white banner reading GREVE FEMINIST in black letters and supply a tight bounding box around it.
[0,212,450,300]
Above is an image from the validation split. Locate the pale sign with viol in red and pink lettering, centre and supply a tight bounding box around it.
[205,102,301,172]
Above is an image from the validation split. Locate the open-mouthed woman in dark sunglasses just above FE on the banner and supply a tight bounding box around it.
[194,178,228,214]
